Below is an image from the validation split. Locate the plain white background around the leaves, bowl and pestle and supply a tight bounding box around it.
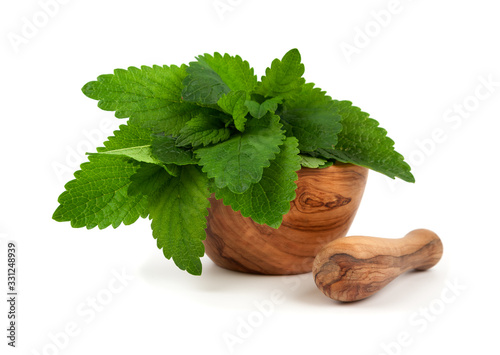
[0,0,500,355]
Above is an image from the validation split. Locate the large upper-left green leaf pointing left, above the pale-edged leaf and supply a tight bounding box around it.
[82,65,201,135]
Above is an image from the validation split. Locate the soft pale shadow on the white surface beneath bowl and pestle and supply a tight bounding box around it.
[139,255,448,313]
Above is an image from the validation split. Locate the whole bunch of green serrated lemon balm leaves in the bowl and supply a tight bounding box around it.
[53,49,414,275]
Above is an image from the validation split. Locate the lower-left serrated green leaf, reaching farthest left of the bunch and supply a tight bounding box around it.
[52,155,148,229]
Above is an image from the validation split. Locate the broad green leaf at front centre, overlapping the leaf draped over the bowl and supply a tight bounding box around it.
[195,115,285,193]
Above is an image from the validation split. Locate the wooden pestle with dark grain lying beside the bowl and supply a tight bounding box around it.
[313,229,443,302]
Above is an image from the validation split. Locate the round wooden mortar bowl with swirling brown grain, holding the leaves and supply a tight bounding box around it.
[204,164,368,275]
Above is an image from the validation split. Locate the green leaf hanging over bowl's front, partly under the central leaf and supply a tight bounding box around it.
[211,137,300,228]
